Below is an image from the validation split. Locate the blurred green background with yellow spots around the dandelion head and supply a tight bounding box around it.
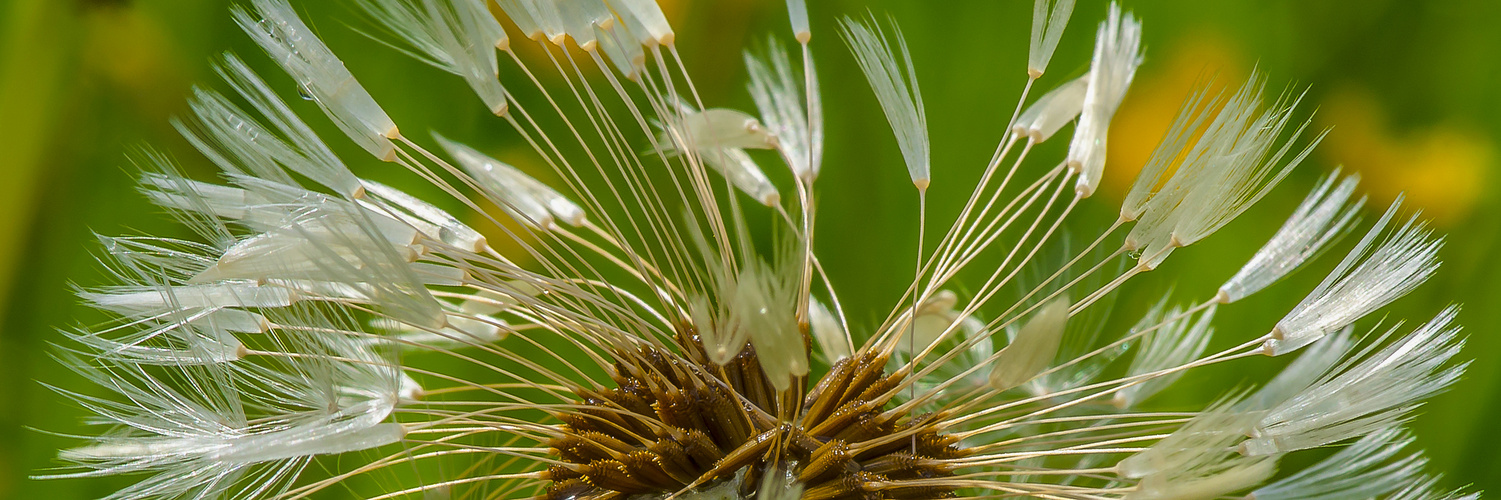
[0,0,1501,498]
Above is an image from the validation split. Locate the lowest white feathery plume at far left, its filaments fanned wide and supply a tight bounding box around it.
[50,308,405,498]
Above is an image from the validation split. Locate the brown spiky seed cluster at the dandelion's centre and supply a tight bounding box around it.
[542,327,965,500]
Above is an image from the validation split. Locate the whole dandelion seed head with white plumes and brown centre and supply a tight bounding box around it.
[41,0,1466,500]
